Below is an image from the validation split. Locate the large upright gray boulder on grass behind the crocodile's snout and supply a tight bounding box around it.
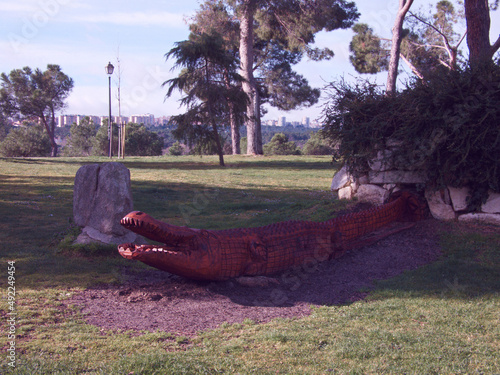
[73,163,137,244]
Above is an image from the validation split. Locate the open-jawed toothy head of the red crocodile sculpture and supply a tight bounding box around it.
[118,211,220,280]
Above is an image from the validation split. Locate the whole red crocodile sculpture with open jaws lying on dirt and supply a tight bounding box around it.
[118,192,425,280]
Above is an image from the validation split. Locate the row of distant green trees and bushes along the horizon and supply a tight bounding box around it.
[0,113,333,157]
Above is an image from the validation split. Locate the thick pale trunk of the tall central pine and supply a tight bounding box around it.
[240,0,264,155]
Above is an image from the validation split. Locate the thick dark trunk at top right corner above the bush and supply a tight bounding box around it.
[465,0,500,67]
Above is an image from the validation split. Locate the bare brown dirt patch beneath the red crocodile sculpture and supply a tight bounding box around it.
[68,219,440,336]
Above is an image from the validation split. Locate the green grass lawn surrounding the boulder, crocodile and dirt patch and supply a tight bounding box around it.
[0,156,500,374]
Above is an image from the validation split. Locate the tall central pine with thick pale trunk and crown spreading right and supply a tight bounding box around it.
[227,0,359,154]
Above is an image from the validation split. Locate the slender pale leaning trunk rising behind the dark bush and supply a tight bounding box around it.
[386,0,413,95]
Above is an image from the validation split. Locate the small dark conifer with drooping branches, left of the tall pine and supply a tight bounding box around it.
[163,33,246,166]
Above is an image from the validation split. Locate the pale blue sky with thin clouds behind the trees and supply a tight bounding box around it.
[0,0,500,120]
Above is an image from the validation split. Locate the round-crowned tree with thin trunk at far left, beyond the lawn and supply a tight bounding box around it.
[0,64,73,157]
